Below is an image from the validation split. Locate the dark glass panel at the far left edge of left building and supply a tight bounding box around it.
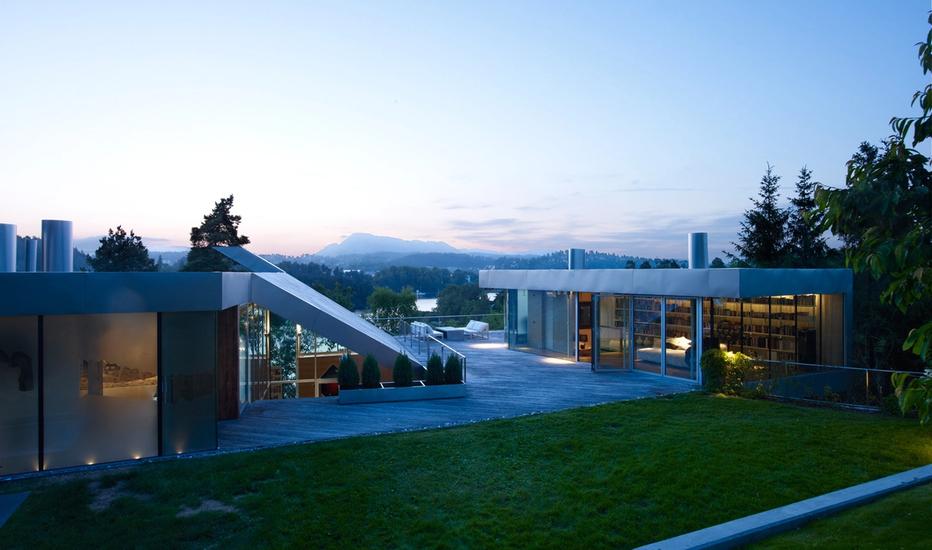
[0,316,39,476]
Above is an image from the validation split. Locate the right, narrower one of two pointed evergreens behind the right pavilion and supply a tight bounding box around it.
[787,166,828,267]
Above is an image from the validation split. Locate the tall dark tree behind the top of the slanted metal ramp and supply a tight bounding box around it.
[181,195,249,271]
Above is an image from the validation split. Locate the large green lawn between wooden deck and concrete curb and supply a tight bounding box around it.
[0,394,932,548]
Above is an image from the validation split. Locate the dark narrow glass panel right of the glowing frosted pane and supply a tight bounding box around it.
[161,311,217,454]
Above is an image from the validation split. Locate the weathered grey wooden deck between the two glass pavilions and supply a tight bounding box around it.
[220,333,696,451]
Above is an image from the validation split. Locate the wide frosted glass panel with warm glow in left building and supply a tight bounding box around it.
[43,313,158,469]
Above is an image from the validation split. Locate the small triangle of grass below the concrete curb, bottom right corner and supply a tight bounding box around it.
[755,483,932,550]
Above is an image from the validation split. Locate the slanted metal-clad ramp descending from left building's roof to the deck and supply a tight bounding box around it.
[215,247,418,367]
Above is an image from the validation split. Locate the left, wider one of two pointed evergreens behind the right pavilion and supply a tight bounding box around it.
[725,163,789,267]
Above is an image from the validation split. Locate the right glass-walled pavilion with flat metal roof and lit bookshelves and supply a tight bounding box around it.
[479,248,853,382]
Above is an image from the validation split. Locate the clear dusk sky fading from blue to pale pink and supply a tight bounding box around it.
[0,0,930,257]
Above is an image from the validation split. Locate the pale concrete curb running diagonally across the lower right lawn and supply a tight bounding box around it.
[637,464,932,550]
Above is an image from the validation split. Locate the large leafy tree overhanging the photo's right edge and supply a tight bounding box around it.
[816,12,932,423]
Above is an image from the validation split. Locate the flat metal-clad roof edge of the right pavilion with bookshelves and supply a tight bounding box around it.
[479,268,854,298]
